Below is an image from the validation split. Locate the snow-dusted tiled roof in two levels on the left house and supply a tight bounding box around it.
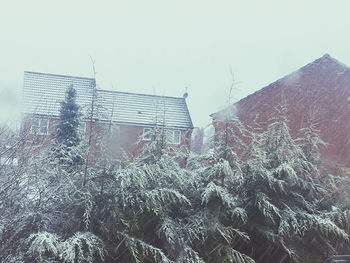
[22,71,193,129]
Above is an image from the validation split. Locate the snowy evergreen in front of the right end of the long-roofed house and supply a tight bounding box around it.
[89,129,202,263]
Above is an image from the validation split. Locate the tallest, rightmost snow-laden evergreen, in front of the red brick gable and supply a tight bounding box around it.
[236,104,348,262]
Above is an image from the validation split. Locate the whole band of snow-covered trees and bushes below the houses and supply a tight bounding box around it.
[0,101,350,263]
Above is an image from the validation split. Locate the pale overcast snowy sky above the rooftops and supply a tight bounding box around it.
[0,0,350,127]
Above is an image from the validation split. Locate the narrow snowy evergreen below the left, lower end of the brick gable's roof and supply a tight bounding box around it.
[188,107,254,263]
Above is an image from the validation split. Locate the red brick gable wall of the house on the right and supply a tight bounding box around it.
[212,54,350,172]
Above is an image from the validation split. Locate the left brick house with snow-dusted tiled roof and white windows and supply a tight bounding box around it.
[22,71,193,158]
